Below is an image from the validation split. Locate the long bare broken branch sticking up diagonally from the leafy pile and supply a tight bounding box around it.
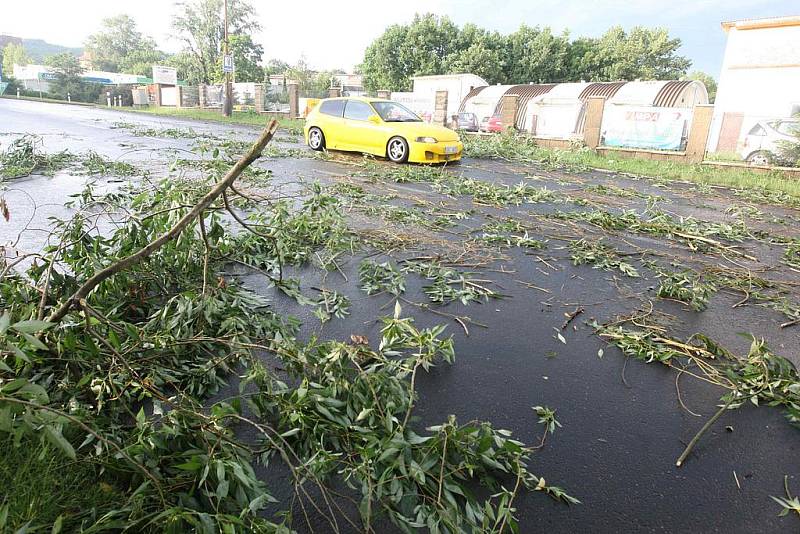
[47,119,278,323]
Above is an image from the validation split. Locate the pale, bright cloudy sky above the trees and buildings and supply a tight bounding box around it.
[0,0,800,78]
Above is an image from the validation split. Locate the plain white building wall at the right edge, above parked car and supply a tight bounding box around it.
[708,17,800,151]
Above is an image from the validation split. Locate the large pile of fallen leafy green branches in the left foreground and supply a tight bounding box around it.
[0,121,576,532]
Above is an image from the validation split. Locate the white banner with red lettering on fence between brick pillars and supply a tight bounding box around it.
[601,104,692,150]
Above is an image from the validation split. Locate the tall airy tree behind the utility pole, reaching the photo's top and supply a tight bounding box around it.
[172,0,261,83]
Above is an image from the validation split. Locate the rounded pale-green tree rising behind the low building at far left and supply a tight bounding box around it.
[86,15,164,74]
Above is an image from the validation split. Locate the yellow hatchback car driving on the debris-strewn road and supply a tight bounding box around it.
[305,97,464,163]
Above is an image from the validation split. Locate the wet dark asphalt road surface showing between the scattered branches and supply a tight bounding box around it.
[0,99,800,533]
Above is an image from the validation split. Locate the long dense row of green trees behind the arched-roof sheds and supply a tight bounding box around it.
[359,14,691,91]
